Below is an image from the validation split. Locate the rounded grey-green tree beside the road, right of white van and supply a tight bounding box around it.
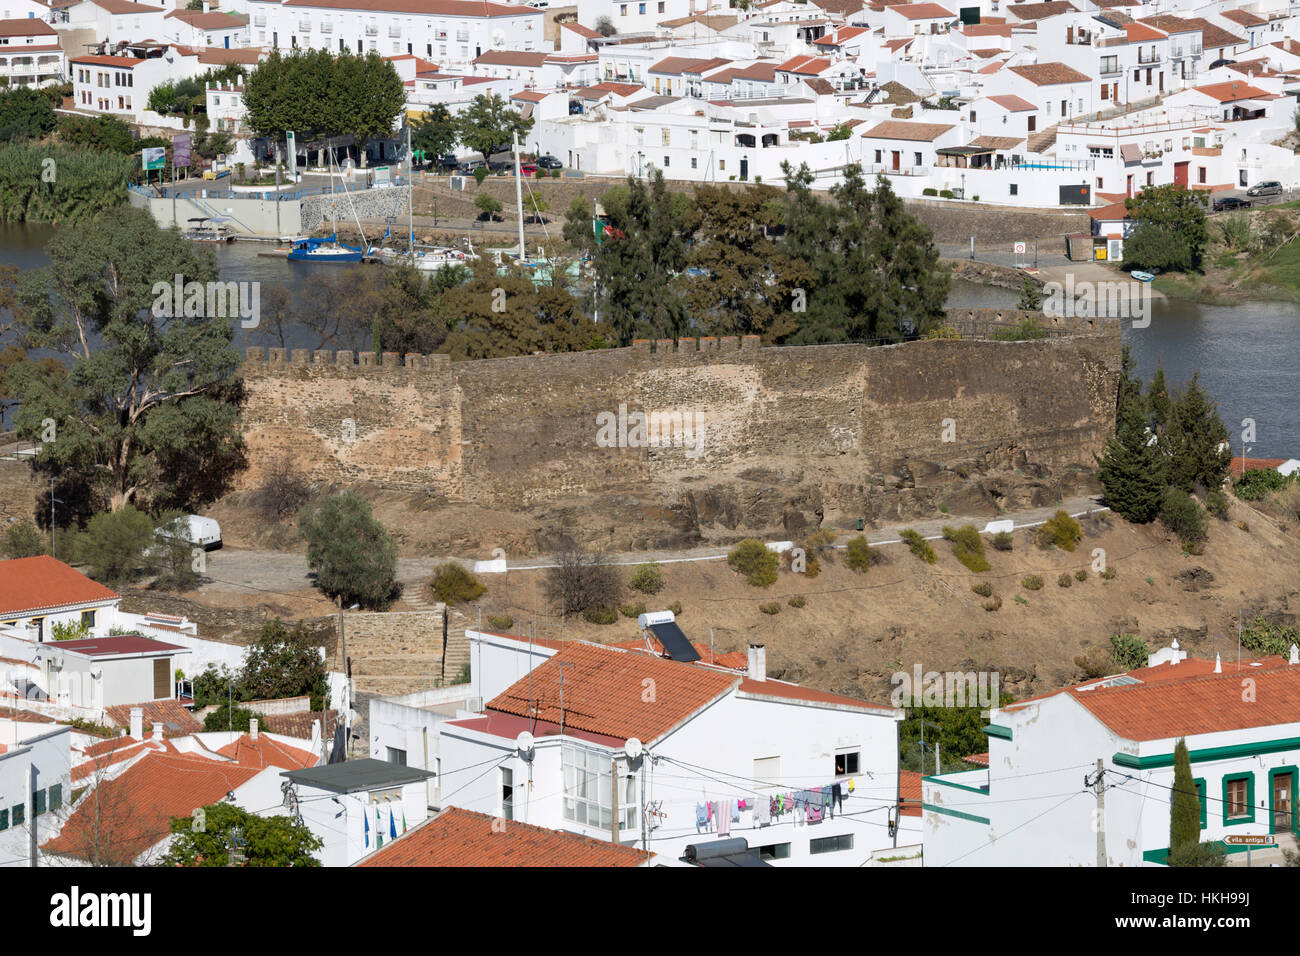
[298,492,400,610]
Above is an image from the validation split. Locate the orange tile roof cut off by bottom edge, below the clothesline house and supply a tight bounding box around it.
[358,806,647,866]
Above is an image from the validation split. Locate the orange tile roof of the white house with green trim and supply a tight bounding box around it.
[1071,661,1300,740]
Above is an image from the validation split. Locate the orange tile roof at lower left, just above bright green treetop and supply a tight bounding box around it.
[43,753,261,865]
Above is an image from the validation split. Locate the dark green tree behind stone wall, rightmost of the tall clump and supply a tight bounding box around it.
[783,164,949,343]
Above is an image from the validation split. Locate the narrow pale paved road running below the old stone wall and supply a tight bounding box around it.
[200,496,1108,594]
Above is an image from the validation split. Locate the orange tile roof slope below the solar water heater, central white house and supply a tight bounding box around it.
[488,644,738,743]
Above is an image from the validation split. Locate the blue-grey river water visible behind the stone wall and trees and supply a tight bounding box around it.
[0,224,1300,458]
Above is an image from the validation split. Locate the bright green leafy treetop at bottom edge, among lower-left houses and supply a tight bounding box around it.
[159,803,324,868]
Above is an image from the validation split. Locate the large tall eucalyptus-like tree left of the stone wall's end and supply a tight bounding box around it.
[7,207,246,511]
